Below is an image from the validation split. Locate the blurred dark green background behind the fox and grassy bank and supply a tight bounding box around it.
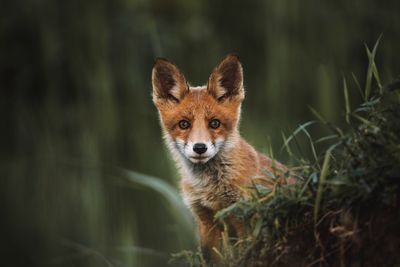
[0,0,400,266]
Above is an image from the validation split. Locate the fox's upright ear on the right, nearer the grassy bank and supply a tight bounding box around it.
[207,55,244,102]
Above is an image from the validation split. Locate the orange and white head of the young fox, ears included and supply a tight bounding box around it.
[152,55,244,164]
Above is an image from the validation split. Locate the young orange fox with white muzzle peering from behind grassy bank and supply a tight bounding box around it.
[151,55,289,261]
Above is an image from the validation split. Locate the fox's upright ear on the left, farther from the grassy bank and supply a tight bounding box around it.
[151,58,189,104]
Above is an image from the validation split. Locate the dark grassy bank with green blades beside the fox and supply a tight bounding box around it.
[172,43,400,267]
